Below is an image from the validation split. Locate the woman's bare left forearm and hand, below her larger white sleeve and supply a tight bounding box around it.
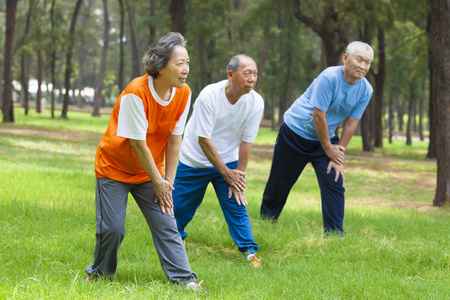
[130,139,173,216]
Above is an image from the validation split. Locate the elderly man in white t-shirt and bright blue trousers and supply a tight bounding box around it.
[172,54,264,267]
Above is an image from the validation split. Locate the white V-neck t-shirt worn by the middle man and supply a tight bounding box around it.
[180,80,264,168]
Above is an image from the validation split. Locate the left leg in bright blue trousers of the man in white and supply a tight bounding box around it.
[172,162,211,239]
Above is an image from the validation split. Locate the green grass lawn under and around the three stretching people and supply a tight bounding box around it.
[0,109,450,299]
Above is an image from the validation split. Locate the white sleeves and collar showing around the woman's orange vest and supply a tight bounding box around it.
[117,76,192,141]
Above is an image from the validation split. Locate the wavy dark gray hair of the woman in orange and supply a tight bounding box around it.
[142,32,187,79]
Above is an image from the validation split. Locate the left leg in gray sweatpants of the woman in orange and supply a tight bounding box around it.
[86,178,132,276]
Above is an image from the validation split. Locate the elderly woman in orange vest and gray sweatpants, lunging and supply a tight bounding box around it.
[86,33,200,289]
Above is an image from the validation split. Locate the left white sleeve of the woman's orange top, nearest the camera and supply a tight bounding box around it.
[117,94,148,141]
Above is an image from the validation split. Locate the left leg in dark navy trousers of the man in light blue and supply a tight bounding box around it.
[261,124,309,220]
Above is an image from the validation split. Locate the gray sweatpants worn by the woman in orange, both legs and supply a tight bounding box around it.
[86,178,197,284]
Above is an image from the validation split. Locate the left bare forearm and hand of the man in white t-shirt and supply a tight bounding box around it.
[198,137,246,191]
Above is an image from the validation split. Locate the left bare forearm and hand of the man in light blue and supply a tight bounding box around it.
[313,107,348,165]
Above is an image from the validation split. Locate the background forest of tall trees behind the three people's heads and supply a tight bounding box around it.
[0,0,449,206]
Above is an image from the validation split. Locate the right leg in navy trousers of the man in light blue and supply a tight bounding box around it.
[312,156,345,234]
